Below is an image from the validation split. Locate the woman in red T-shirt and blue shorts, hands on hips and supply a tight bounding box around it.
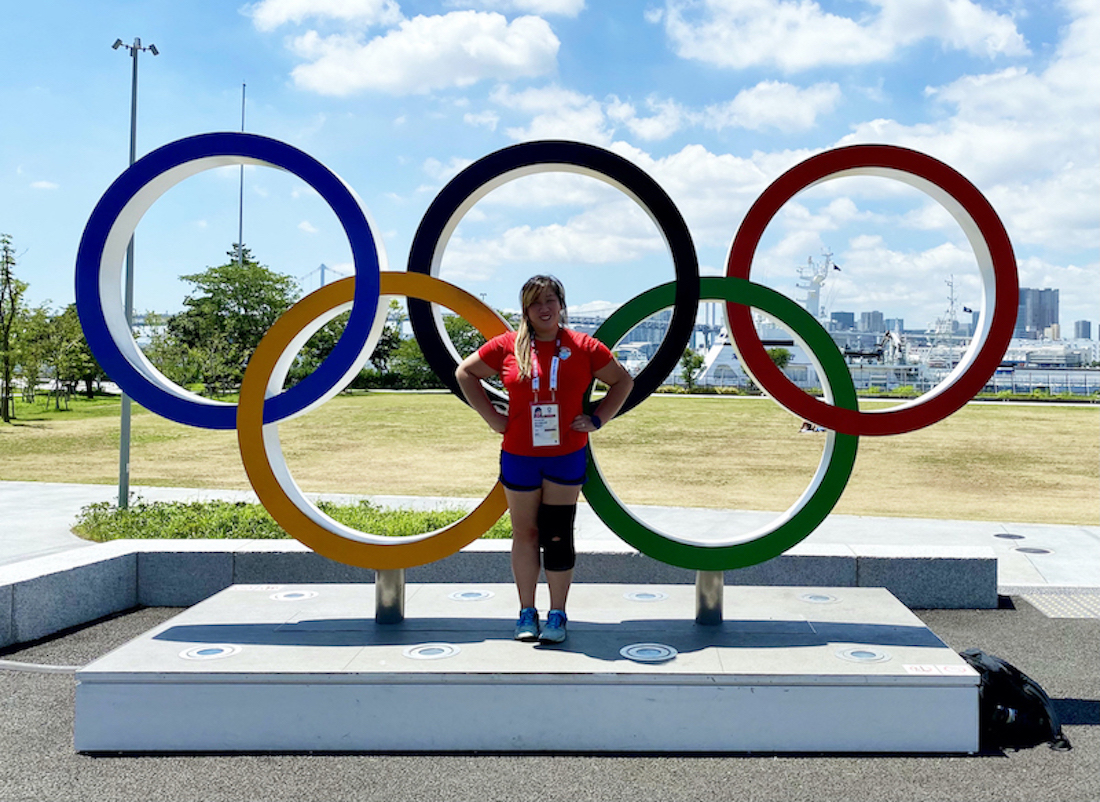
[455,276,634,644]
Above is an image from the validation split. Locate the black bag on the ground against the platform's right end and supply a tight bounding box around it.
[959,649,1073,751]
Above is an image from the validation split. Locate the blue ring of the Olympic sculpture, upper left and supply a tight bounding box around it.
[76,133,381,429]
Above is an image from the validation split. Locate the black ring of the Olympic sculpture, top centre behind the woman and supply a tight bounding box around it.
[408,140,700,415]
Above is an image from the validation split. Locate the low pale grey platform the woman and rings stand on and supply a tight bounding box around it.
[75,584,978,754]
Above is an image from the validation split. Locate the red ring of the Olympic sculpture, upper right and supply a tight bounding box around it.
[726,145,1020,435]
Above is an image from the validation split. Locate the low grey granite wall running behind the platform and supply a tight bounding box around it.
[0,540,998,647]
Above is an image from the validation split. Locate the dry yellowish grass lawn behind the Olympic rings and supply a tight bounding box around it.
[0,393,1100,525]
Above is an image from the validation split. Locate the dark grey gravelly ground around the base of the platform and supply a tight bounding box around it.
[0,597,1100,802]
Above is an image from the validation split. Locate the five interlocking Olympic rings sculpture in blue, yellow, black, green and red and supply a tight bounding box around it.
[76,133,1019,571]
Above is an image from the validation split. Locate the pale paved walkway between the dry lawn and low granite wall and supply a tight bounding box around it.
[0,482,1100,592]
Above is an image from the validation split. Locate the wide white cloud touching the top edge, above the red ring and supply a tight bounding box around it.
[662,0,1027,73]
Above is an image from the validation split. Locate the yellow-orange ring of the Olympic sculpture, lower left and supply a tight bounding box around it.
[237,272,509,569]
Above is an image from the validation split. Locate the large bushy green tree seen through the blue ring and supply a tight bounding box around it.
[158,244,298,395]
